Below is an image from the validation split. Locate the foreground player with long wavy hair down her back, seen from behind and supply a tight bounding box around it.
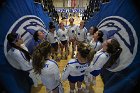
[33,41,63,93]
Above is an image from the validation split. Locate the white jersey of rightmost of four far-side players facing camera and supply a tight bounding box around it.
[76,27,87,41]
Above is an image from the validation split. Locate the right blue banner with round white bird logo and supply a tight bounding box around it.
[86,0,140,93]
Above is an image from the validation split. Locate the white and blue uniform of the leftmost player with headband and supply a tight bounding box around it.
[7,44,40,87]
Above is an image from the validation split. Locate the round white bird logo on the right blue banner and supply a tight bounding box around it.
[98,16,138,72]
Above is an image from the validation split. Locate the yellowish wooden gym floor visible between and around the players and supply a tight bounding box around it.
[31,17,104,93]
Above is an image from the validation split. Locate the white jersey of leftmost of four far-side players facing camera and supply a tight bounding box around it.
[47,31,58,44]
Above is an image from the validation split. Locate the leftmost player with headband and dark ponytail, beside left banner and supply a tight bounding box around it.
[6,33,40,87]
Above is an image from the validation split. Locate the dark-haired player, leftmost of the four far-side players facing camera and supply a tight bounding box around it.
[46,22,59,60]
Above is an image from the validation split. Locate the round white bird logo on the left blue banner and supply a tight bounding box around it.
[4,15,45,55]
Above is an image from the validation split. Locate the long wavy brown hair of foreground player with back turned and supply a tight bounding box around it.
[32,41,51,74]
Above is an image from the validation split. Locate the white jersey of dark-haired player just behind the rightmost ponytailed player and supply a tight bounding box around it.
[89,39,102,51]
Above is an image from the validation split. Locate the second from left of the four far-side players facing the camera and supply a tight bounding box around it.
[57,22,68,59]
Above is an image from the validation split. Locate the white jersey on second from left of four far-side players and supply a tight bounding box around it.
[57,28,68,41]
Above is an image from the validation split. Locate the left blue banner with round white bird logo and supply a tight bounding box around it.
[0,0,50,93]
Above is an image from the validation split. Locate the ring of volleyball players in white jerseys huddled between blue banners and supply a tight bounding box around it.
[7,18,122,93]
